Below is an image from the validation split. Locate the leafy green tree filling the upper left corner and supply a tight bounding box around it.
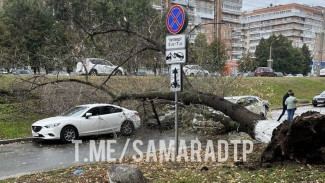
[0,0,68,72]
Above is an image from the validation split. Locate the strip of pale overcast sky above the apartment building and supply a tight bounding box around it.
[243,0,325,11]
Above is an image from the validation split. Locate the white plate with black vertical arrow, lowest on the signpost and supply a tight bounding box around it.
[170,64,183,92]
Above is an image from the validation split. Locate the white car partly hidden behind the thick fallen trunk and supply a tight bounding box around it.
[225,96,270,116]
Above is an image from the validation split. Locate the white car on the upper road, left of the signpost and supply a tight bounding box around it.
[76,58,126,76]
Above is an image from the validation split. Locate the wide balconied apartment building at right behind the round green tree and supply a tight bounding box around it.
[232,4,323,59]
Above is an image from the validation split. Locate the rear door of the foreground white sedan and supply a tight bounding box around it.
[100,106,126,133]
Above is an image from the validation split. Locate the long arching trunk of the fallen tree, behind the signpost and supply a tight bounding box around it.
[115,92,265,137]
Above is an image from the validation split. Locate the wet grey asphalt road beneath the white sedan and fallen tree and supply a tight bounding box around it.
[0,106,325,180]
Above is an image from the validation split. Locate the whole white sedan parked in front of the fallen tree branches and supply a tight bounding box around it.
[32,104,140,142]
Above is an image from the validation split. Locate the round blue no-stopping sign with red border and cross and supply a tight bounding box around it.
[166,5,188,34]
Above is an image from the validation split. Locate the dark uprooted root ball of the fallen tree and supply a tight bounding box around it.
[261,111,325,164]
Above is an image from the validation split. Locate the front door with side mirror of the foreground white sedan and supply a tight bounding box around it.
[78,107,102,135]
